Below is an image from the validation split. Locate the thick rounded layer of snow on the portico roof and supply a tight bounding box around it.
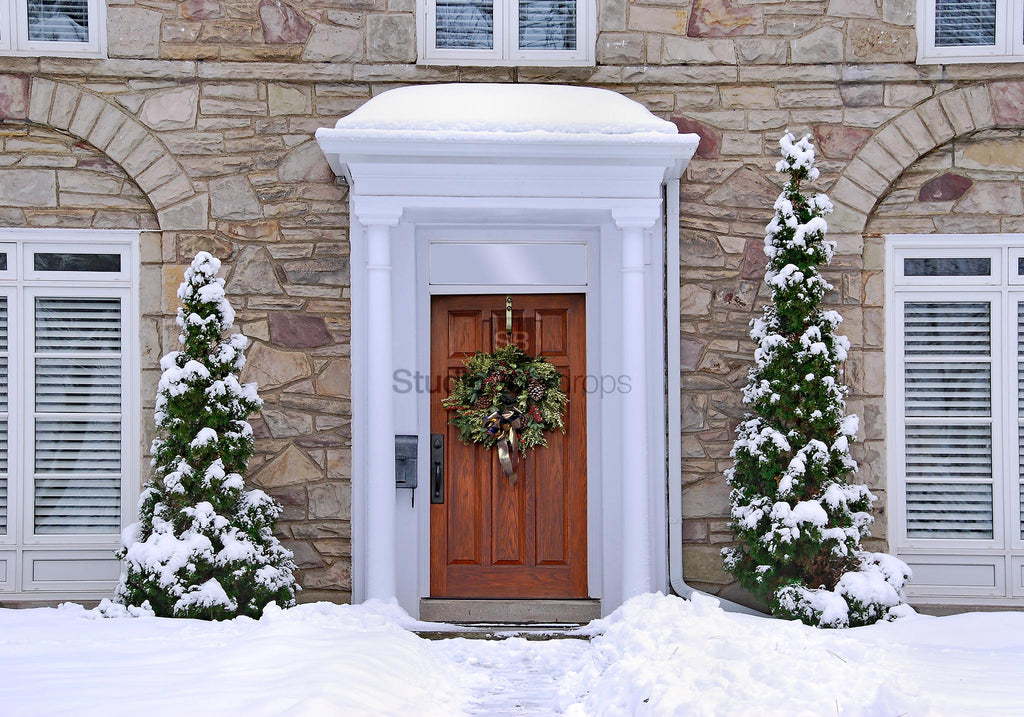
[317,83,696,145]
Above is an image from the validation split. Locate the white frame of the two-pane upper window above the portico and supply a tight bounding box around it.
[415,0,593,67]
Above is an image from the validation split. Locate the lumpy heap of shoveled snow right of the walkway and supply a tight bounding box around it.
[560,594,929,717]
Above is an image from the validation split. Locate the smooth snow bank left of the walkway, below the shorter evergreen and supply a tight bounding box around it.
[0,603,470,717]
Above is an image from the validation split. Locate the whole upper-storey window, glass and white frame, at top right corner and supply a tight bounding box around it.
[918,0,1024,62]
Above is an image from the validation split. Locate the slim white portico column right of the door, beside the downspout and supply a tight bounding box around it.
[613,212,656,600]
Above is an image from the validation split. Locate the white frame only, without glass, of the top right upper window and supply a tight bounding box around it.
[918,0,1024,65]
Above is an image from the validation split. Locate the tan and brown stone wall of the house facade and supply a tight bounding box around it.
[0,0,1024,600]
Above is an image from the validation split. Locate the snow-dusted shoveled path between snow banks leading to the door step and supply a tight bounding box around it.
[425,636,590,717]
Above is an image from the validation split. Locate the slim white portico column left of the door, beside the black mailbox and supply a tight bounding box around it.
[358,205,398,600]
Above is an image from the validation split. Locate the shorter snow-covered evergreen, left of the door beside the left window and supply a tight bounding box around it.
[117,252,297,620]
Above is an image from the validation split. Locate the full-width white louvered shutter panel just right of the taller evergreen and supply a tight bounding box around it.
[903,301,993,540]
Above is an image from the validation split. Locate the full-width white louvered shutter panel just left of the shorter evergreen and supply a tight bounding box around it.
[34,297,123,535]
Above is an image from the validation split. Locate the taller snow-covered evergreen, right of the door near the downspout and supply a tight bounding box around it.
[723,133,910,627]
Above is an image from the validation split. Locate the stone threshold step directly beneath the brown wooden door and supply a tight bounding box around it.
[420,597,601,625]
